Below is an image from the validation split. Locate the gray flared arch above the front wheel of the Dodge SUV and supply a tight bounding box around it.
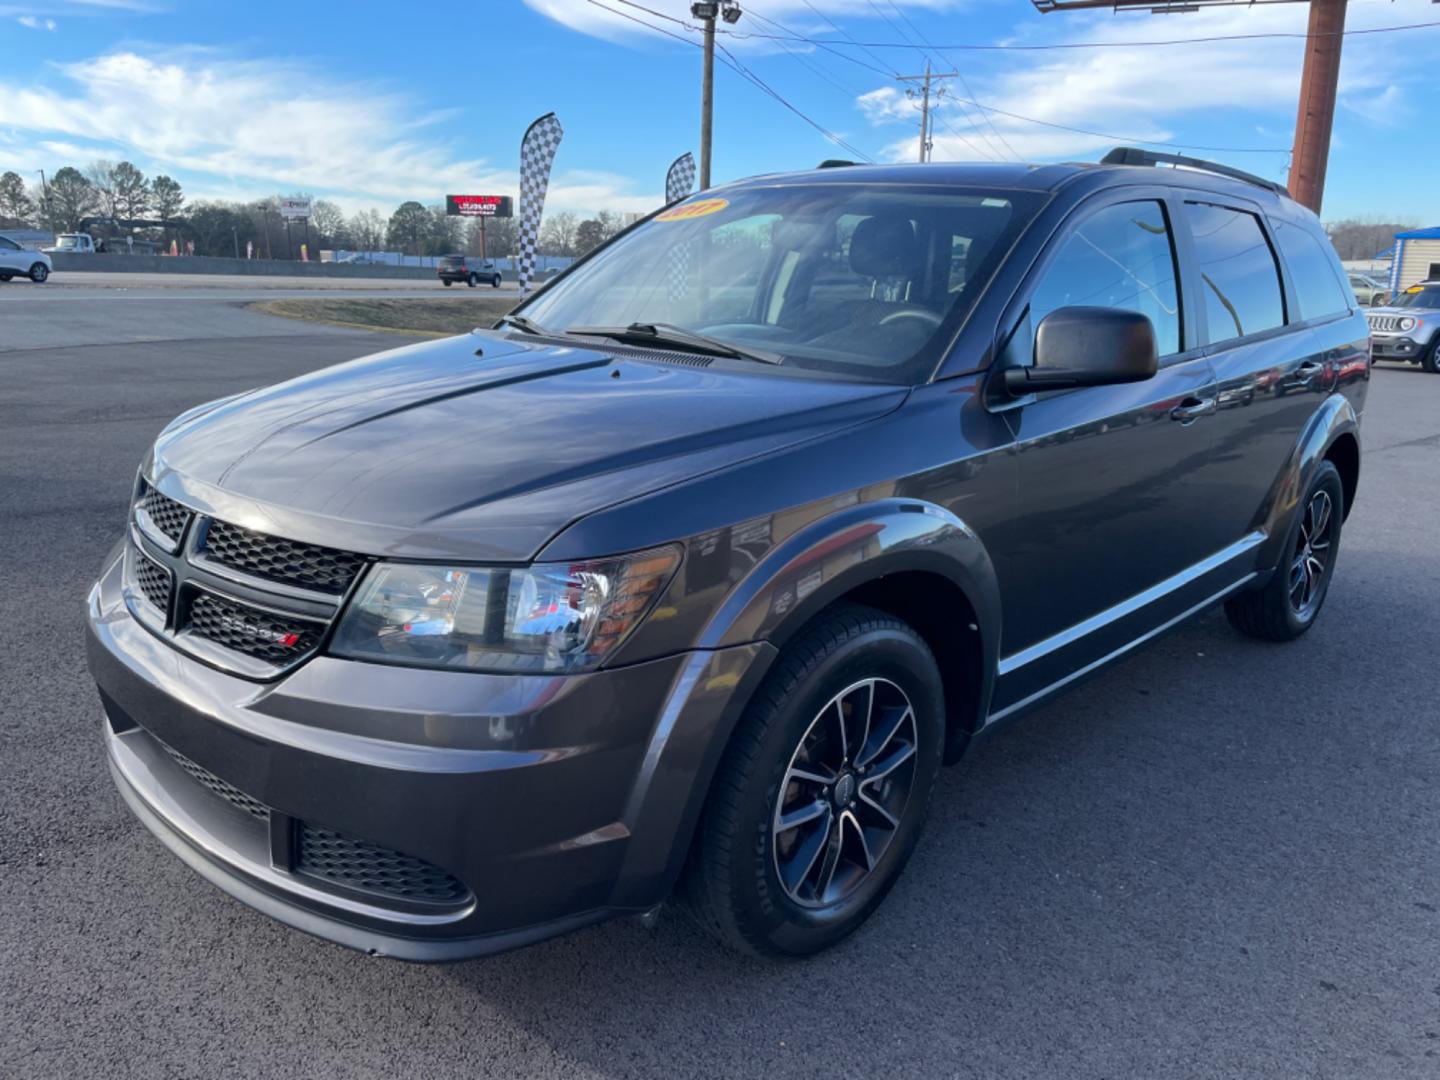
[698,498,1001,716]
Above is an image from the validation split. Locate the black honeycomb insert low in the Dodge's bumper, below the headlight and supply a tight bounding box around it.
[295,822,469,907]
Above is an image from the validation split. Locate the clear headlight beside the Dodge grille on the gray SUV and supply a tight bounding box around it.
[330,547,680,672]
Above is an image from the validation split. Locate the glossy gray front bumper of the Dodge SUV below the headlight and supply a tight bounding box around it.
[86,559,773,960]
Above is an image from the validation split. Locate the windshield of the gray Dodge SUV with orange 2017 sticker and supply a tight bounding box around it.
[521,183,1041,382]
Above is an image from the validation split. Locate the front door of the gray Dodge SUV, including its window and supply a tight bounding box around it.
[995,189,1225,713]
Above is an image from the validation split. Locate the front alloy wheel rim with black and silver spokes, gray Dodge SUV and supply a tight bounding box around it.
[770,678,917,907]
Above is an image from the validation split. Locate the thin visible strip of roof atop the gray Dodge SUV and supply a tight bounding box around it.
[711,161,1299,208]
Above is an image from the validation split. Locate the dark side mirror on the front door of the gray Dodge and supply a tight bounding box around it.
[1002,307,1159,397]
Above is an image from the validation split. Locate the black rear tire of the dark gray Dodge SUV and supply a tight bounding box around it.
[1225,461,1345,641]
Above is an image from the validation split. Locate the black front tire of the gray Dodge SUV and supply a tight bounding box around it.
[680,605,945,958]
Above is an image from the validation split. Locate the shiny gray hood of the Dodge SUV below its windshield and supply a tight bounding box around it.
[145,333,906,562]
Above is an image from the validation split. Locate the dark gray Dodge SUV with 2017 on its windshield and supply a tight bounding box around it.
[88,151,1369,960]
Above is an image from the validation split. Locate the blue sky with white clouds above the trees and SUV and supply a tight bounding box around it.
[0,0,1440,225]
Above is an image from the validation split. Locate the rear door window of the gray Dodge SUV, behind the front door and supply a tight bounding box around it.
[1185,203,1284,344]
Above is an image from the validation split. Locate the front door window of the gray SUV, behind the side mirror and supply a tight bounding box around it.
[1030,202,1181,356]
